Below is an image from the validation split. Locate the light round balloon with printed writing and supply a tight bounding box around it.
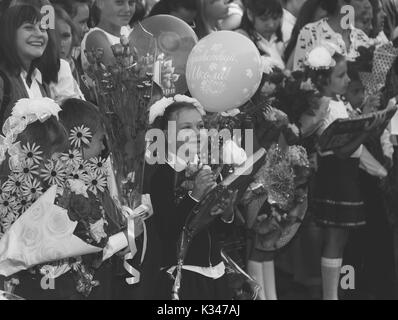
[186,31,262,112]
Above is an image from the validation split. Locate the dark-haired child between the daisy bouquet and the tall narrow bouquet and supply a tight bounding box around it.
[60,99,155,300]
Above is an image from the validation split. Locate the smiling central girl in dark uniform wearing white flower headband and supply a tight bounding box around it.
[150,95,236,300]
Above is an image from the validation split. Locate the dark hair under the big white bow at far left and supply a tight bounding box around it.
[17,117,68,160]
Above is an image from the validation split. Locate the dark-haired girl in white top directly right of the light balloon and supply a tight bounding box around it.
[238,0,285,70]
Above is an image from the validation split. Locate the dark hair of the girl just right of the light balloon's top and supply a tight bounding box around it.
[240,0,283,43]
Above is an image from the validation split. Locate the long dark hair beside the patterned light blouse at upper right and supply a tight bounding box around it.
[285,0,323,63]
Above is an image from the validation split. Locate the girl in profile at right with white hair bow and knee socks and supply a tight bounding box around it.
[306,47,384,300]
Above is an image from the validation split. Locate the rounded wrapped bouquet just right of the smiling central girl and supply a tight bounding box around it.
[244,145,310,251]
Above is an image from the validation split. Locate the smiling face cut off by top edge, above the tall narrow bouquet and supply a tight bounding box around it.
[99,0,136,27]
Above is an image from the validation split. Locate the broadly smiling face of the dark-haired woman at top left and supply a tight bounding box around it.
[15,21,48,62]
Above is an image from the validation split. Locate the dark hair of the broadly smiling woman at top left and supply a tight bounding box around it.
[0,5,42,75]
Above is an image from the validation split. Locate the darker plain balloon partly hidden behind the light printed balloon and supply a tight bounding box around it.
[142,15,198,97]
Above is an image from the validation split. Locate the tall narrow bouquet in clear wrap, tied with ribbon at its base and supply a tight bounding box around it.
[86,25,156,209]
